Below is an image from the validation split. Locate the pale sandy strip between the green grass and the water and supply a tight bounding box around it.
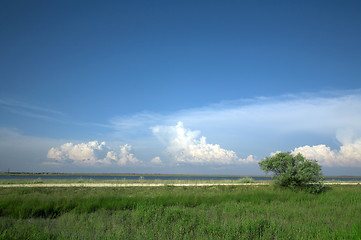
[0,182,361,188]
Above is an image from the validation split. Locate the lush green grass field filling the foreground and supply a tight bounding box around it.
[0,186,361,239]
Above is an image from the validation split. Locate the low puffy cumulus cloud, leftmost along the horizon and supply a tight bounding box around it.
[44,141,140,165]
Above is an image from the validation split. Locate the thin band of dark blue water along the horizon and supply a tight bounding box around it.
[0,174,361,182]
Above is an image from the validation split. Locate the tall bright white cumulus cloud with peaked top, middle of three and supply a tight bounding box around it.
[152,122,242,164]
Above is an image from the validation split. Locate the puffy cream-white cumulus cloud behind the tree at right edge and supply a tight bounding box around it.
[292,138,361,167]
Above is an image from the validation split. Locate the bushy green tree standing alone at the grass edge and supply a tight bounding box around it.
[258,152,324,193]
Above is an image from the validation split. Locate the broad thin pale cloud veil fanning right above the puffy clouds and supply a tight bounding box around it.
[112,90,361,163]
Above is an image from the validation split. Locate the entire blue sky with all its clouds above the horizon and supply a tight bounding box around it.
[0,0,361,176]
